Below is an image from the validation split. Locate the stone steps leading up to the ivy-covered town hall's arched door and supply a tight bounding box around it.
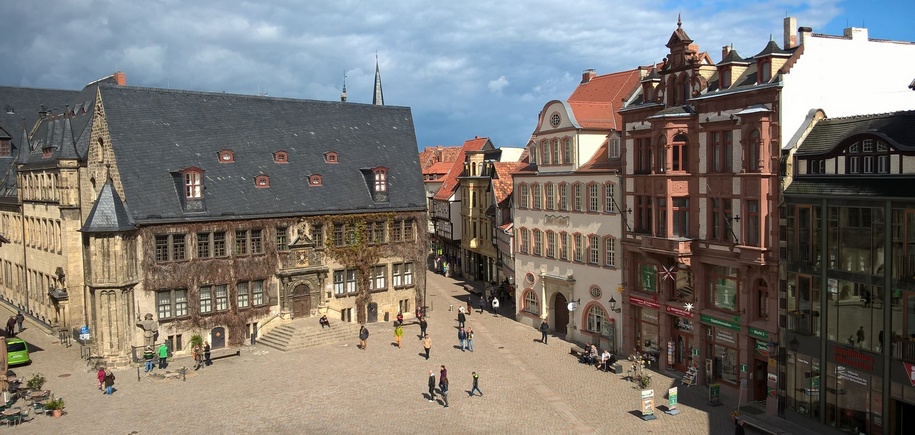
[257,318,368,352]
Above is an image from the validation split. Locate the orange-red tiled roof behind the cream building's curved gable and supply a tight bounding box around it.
[568,69,641,130]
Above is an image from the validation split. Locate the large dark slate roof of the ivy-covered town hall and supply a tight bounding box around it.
[68,83,426,224]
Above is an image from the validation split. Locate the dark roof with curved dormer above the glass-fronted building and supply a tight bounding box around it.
[795,111,915,157]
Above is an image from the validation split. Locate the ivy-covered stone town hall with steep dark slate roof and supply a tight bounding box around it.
[0,73,426,363]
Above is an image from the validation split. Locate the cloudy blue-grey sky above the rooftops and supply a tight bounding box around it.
[0,0,915,148]
